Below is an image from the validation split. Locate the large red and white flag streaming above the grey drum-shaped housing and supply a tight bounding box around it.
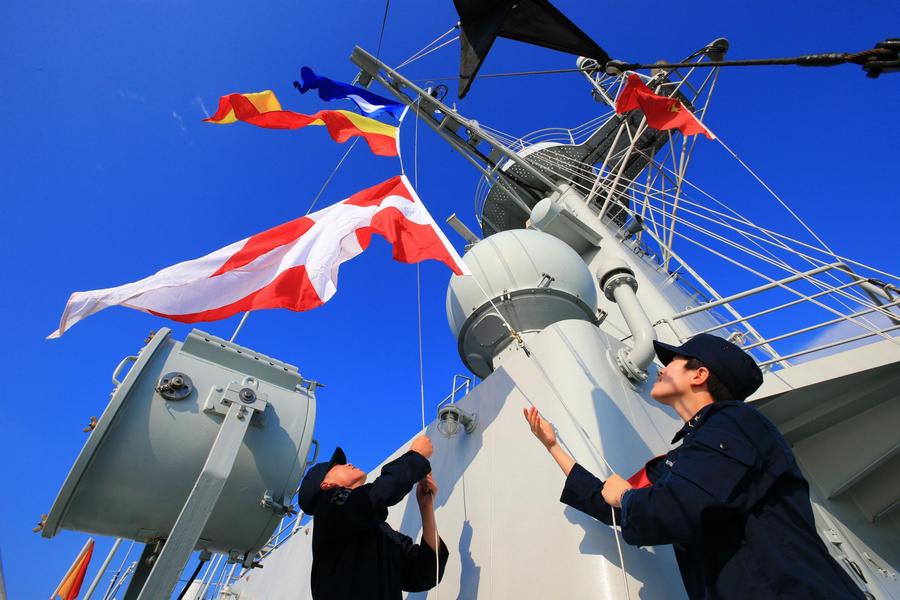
[48,175,471,338]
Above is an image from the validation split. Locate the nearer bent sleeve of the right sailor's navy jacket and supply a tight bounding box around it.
[621,423,759,546]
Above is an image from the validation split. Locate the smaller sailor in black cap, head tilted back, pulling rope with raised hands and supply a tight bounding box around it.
[298,435,449,600]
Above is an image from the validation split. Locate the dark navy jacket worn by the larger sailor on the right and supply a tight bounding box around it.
[560,401,864,599]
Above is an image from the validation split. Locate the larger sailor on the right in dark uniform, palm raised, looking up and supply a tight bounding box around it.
[525,334,864,599]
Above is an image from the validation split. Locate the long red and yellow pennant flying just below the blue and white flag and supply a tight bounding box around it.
[203,90,397,156]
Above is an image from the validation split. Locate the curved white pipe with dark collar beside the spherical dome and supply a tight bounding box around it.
[597,258,656,383]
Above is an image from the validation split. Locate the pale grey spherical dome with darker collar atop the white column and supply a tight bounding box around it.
[447,229,597,377]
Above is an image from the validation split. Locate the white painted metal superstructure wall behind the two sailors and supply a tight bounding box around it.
[234,320,683,600]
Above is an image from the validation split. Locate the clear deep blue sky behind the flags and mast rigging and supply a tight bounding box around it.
[0,0,900,598]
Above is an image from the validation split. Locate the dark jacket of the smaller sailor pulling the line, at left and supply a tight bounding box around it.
[310,451,449,600]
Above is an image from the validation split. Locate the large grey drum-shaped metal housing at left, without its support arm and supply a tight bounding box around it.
[43,328,316,556]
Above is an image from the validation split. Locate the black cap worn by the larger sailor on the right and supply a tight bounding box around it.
[653,333,762,400]
